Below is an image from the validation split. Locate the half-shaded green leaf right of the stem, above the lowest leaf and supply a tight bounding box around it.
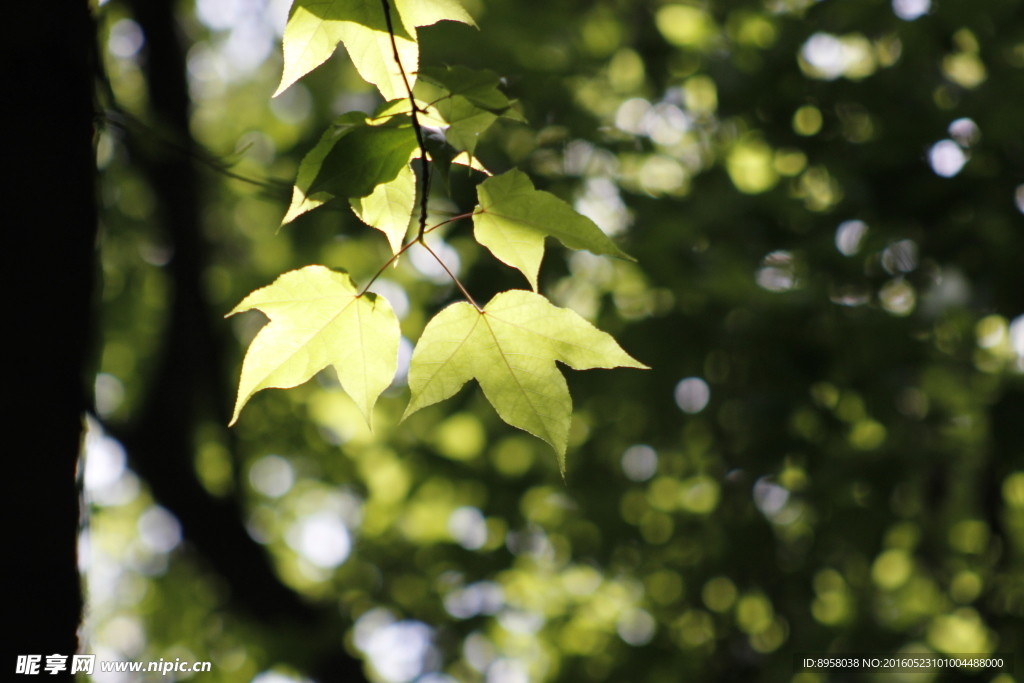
[473,169,634,292]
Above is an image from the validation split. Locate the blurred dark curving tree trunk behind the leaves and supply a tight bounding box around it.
[110,0,364,682]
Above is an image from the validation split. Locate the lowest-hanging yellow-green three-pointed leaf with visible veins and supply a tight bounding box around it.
[403,290,646,469]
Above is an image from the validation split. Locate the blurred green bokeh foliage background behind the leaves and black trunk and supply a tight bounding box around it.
[80,0,1024,683]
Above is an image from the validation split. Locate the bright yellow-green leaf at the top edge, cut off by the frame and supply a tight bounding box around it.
[274,0,475,99]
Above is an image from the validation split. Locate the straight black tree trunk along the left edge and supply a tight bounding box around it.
[2,0,96,680]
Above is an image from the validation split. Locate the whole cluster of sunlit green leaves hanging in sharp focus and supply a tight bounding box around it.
[229,0,645,464]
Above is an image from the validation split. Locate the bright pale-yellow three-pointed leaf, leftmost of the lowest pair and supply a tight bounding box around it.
[227,265,400,425]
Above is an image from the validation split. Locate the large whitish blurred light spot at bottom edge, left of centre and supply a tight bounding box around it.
[354,608,433,683]
